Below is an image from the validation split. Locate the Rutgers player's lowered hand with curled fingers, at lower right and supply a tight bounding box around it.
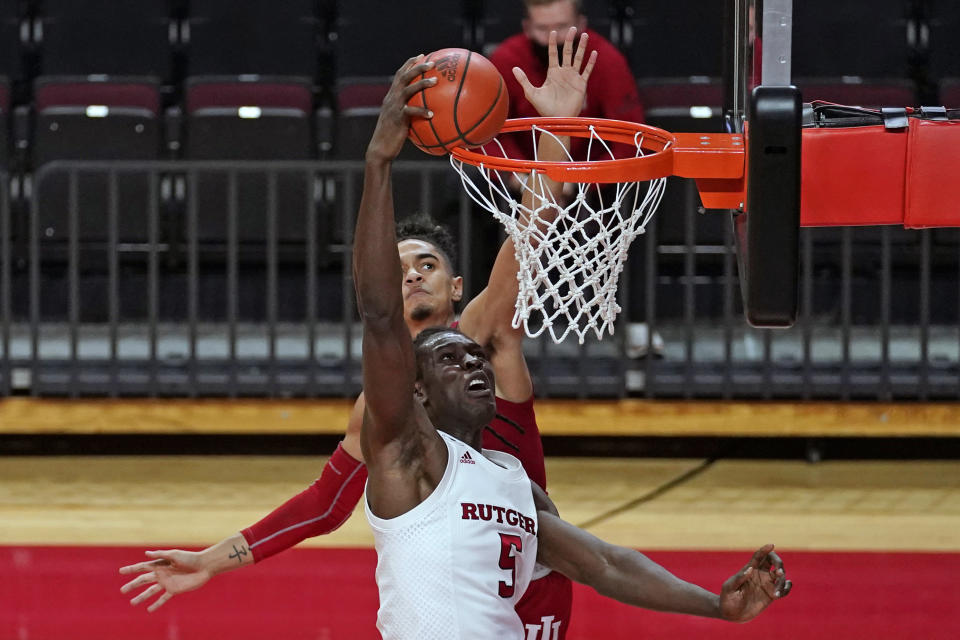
[720,544,793,622]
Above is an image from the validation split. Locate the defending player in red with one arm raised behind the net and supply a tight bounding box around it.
[120,29,597,640]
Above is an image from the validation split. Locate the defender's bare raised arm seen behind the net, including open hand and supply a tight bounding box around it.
[460,28,597,402]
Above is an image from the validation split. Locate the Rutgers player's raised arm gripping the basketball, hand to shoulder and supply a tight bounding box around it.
[353,56,447,518]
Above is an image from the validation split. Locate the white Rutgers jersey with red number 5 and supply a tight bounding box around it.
[366,432,538,640]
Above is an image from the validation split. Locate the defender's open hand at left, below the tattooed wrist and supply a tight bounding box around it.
[120,549,214,612]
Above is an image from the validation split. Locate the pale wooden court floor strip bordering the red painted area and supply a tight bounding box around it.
[0,456,960,551]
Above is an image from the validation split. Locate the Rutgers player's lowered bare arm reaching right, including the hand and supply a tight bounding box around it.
[537,510,793,622]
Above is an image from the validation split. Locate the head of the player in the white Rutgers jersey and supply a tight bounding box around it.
[413,327,496,439]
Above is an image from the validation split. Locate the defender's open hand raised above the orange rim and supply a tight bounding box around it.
[513,27,597,117]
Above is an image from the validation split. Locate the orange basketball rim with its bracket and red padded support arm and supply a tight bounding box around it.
[451,118,960,228]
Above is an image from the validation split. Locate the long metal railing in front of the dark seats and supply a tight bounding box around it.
[0,161,960,400]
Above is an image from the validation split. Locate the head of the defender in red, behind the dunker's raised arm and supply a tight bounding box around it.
[397,214,463,324]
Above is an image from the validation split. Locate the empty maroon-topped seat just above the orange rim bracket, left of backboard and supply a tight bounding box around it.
[637,76,723,133]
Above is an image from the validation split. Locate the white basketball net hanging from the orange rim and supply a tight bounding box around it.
[450,125,666,344]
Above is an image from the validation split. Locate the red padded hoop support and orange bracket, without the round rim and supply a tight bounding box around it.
[673,119,960,229]
